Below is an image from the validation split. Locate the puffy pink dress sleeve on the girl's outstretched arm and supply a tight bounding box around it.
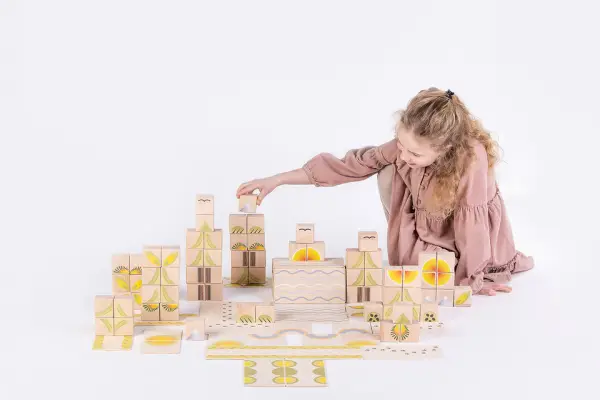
[302,139,399,186]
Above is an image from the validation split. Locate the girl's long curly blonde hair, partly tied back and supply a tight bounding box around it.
[396,87,499,215]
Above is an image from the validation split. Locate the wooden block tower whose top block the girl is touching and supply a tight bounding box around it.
[229,195,267,286]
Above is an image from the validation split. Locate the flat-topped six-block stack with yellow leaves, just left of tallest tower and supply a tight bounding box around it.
[142,246,180,321]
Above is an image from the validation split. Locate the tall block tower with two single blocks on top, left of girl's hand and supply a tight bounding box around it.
[185,194,223,301]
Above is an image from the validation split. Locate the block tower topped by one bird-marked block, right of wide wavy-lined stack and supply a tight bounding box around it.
[346,231,383,303]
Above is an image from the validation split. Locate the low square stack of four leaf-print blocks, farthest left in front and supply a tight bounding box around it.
[94,294,133,336]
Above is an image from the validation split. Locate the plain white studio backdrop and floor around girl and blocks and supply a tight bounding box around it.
[0,0,600,399]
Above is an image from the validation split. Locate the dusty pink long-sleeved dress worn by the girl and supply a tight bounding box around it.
[303,139,534,293]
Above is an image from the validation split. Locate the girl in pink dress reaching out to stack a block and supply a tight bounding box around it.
[237,88,533,296]
